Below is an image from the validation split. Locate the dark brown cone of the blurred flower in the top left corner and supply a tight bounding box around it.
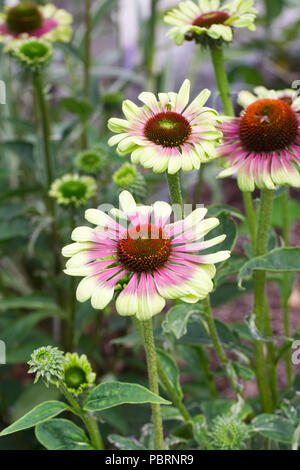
[6,2,43,34]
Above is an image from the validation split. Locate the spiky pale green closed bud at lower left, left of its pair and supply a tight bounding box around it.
[28,346,65,386]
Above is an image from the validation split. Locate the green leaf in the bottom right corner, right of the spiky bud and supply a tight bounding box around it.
[252,414,295,444]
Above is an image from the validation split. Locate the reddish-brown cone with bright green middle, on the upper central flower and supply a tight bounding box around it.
[144,111,192,147]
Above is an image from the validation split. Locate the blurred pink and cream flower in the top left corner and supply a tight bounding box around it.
[0,1,72,50]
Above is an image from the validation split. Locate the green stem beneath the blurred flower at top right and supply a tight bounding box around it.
[210,46,234,116]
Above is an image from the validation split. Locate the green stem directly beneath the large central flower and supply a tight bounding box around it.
[140,319,164,450]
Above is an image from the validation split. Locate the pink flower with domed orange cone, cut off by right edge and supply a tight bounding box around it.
[218,92,300,191]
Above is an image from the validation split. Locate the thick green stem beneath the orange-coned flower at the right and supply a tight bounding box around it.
[254,189,273,413]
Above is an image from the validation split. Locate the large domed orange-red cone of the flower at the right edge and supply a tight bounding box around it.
[240,99,298,152]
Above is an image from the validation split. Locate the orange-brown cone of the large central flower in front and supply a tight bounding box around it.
[118,224,171,273]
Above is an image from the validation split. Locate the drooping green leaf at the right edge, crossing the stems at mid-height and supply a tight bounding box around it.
[238,247,300,287]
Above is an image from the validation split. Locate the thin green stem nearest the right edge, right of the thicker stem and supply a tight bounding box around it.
[282,189,293,388]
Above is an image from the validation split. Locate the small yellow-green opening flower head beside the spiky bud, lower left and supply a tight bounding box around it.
[64,353,96,395]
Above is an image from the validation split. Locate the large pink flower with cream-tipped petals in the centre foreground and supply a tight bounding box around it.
[62,191,230,320]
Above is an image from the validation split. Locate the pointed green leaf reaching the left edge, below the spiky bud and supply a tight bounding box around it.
[0,400,69,436]
